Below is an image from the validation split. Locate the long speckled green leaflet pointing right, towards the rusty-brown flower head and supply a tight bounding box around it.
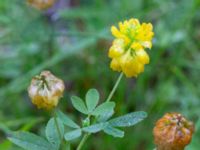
[109,111,147,127]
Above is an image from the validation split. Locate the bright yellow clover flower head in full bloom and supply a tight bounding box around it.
[108,19,154,77]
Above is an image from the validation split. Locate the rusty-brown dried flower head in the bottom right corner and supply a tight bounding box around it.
[153,113,194,150]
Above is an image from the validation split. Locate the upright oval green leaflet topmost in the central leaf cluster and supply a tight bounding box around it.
[85,89,99,112]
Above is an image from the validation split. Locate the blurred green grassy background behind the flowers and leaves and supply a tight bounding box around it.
[0,0,200,150]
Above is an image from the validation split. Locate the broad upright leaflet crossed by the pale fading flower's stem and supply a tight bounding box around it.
[45,118,64,150]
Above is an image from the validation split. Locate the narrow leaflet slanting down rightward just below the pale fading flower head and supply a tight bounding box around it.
[57,110,80,128]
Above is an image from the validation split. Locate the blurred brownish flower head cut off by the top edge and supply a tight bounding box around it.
[27,0,55,10]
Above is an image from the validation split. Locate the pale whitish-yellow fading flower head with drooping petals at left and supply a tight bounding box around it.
[28,71,65,109]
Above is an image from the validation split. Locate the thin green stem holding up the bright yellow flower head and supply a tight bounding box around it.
[76,72,123,150]
